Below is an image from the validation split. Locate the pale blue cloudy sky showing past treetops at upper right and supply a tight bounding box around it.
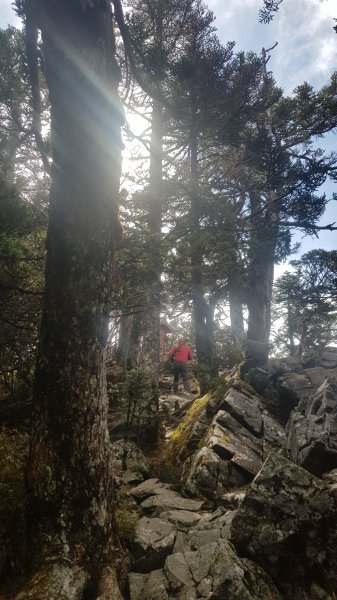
[0,0,337,253]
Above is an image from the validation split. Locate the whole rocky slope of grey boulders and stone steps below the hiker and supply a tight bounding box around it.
[115,350,337,600]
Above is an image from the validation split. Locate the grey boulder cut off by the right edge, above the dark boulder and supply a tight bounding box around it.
[287,379,337,476]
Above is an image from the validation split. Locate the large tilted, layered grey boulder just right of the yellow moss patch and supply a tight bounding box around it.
[182,388,284,500]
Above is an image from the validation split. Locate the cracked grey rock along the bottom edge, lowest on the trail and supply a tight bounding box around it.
[129,540,282,600]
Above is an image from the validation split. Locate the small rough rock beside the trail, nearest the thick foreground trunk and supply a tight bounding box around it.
[111,440,150,483]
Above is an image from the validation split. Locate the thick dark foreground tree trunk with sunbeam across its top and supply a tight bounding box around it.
[21,0,126,599]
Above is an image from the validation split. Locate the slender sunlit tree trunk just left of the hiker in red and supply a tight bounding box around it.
[140,100,163,445]
